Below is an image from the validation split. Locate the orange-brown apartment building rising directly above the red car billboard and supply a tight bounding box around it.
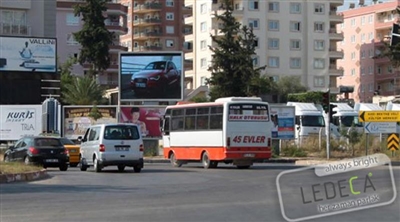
[121,0,190,52]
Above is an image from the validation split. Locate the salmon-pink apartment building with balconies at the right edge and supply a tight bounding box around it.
[337,0,400,102]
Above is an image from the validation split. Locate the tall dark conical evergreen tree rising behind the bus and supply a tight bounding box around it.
[207,0,265,100]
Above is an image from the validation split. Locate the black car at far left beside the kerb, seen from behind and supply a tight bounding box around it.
[4,136,69,171]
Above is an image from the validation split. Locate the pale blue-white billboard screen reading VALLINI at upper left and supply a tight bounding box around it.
[0,36,57,73]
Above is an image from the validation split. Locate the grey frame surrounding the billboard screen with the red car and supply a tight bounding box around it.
[118,51,185,102]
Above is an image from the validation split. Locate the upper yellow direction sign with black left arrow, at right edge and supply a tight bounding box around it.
[358,111,400,122]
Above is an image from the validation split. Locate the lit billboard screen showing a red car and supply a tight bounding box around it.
[119,52,184,101]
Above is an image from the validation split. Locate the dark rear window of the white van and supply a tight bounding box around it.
[104,126,140,140]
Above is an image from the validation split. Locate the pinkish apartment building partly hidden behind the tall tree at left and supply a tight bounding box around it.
[57,0,128,88]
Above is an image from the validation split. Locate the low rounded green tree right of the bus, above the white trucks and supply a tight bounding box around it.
[276,76,307,102]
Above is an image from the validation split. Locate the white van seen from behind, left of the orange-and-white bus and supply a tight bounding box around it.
[78,123,143,173]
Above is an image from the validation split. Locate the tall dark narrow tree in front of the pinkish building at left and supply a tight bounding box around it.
[73,0,113,76]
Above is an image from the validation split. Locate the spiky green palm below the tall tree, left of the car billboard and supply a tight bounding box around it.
[61,76,105,105]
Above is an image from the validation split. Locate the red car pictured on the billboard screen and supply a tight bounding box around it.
[131,61,181,95]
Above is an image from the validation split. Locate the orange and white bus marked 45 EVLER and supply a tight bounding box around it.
[161,97,273,169]
